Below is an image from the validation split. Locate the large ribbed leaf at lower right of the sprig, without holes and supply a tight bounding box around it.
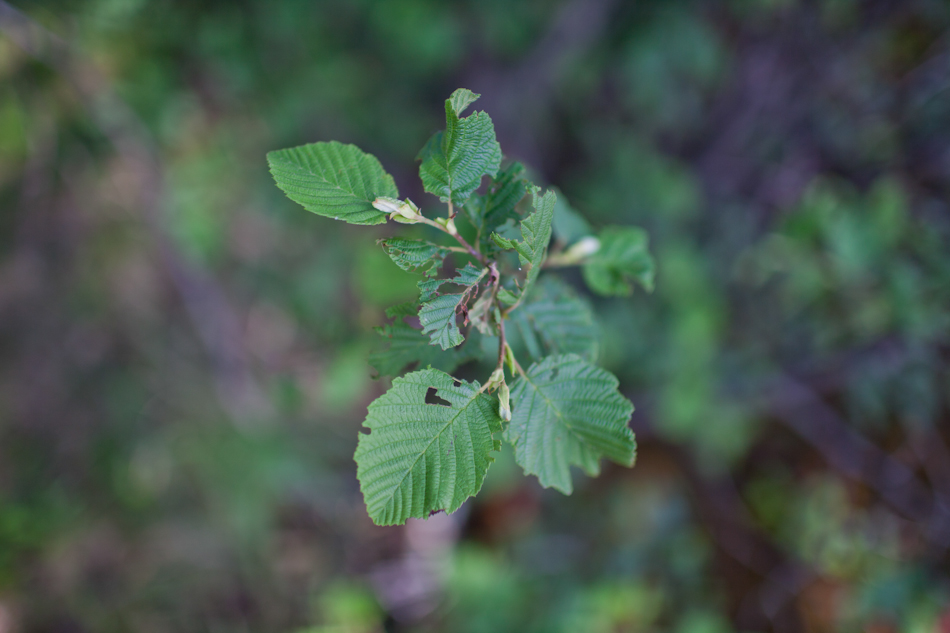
[505,354,636,494]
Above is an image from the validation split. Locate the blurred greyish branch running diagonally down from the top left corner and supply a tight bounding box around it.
[0,0,268,421]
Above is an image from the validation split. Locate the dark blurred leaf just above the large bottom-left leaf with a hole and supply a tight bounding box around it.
[369,302,474,376]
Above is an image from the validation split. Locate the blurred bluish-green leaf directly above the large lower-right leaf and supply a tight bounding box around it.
[508,274,600,362]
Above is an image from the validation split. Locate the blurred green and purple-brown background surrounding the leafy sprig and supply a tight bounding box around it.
[0,0,950,633]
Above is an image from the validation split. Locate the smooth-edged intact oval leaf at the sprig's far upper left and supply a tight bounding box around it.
[267,141,399,224]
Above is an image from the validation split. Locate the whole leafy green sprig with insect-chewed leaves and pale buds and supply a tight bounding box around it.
[267,89,655,525]
